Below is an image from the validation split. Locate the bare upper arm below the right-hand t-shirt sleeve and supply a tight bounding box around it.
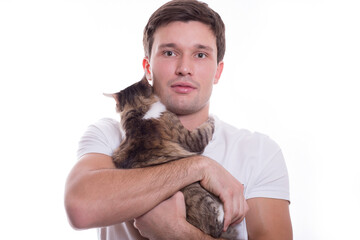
[246,198,293,240]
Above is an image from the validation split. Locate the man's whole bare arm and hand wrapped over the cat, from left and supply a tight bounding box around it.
[65,153,244,229]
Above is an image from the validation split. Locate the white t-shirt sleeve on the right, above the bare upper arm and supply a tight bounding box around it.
[246,137,290,201]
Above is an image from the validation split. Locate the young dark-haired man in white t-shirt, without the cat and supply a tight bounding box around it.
[65,0,292,240]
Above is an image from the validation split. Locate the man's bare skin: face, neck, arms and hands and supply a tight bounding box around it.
[65,22,292,239]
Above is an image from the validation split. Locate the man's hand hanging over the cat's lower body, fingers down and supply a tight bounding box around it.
[200,158,249,231]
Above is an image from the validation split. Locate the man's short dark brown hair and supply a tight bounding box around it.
[143,0,225,63]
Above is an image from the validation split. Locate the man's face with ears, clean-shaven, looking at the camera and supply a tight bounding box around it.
[144,21,223,115]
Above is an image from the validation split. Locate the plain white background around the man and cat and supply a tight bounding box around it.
[0,0,360,240]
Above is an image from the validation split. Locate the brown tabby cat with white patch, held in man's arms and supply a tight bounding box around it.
[112,76,237,239]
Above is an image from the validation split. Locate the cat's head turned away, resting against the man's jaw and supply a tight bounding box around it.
[104,77,154,113]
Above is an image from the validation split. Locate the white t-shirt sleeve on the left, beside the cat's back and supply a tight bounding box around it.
[77,118,122,159]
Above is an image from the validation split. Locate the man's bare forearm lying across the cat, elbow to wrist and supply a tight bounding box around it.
[65,155,202,228]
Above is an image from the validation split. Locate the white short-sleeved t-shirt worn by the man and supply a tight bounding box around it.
[78,117,290,240]
